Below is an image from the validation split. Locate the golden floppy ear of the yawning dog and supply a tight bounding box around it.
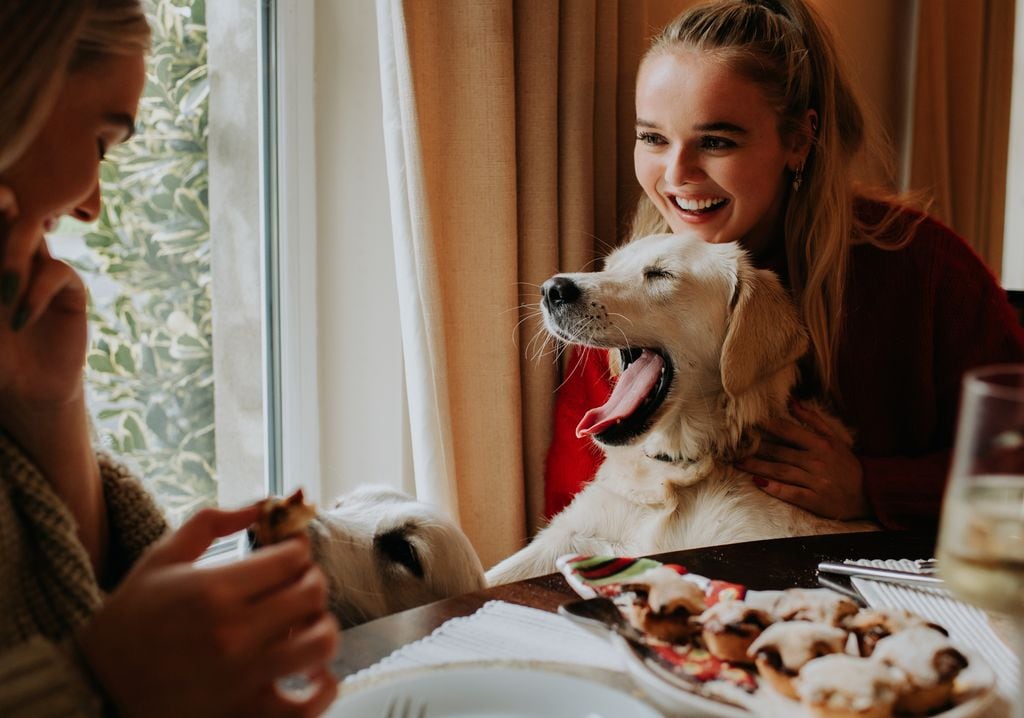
[721,258,807,399]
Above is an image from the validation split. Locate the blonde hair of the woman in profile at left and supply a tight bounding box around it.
[0,0,150,171]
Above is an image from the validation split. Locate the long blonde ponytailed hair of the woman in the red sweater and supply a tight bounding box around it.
[630,0,907,402]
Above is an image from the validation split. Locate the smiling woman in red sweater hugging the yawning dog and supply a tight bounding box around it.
[546,0,1024,529]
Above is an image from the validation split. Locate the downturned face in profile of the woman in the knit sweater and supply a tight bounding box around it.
[0,52,145,231]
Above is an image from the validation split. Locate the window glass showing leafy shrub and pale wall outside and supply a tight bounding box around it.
[51,0,274,523]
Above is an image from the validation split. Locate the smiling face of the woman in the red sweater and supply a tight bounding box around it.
[633,50,804,254]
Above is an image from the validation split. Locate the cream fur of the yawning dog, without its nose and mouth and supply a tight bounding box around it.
[487,235,877,585]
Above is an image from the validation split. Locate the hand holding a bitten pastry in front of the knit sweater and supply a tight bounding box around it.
[78,505,338,716]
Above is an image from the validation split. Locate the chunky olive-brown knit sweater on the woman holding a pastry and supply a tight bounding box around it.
[0,432,167,718]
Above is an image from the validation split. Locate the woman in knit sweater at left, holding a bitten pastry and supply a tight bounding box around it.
[0,0,337,716]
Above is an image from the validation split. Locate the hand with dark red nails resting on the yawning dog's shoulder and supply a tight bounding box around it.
[736,402,871,520]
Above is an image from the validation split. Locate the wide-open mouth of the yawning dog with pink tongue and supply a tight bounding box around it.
[577,349,672,447]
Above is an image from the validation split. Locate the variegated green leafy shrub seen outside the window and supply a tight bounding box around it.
[75,0,217,522]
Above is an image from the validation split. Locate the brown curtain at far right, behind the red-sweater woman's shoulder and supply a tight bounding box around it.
[908,0,1014,277]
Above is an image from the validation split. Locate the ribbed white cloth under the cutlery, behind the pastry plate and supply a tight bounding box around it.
[847,558,1020,698]
